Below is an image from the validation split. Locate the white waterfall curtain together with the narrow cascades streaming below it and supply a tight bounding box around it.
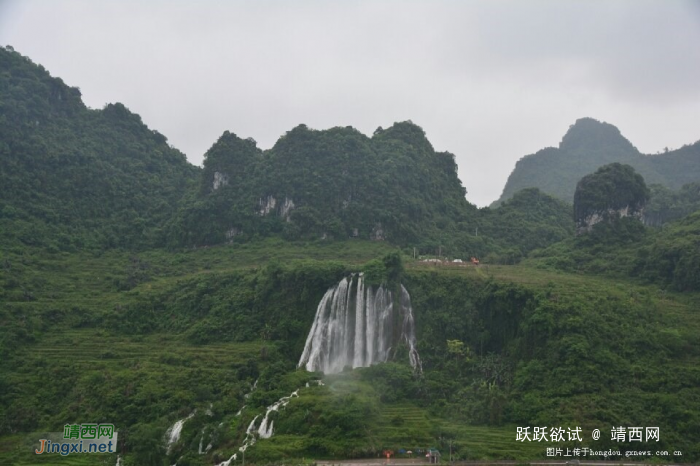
[165,273,422,466]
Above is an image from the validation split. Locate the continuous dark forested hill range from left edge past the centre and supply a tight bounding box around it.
[0,47,573,262]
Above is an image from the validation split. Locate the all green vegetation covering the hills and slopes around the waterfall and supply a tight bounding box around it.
[0,44,700,466]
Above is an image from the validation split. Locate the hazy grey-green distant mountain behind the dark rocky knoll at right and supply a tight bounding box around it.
[494,118,700,205]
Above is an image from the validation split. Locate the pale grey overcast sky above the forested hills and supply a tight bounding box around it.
[0,0,700,206]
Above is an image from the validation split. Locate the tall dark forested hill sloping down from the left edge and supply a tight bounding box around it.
[0,47,198,250]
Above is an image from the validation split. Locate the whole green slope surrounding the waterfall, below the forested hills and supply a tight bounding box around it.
[0,240,700,466]
